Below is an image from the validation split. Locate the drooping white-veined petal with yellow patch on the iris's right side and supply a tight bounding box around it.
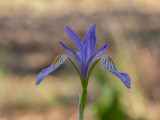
[98,55,131,88]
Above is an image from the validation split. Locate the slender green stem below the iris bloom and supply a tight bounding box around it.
[78,89,87,120]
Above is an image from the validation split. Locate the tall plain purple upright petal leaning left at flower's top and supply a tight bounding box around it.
[66,26,82,52]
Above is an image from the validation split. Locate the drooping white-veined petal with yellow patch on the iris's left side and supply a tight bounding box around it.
[36,55,78,85]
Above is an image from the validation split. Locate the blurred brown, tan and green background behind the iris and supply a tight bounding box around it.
[0,0,160,120]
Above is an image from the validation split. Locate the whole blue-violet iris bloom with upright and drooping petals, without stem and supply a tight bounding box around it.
[36,25,131,88]
